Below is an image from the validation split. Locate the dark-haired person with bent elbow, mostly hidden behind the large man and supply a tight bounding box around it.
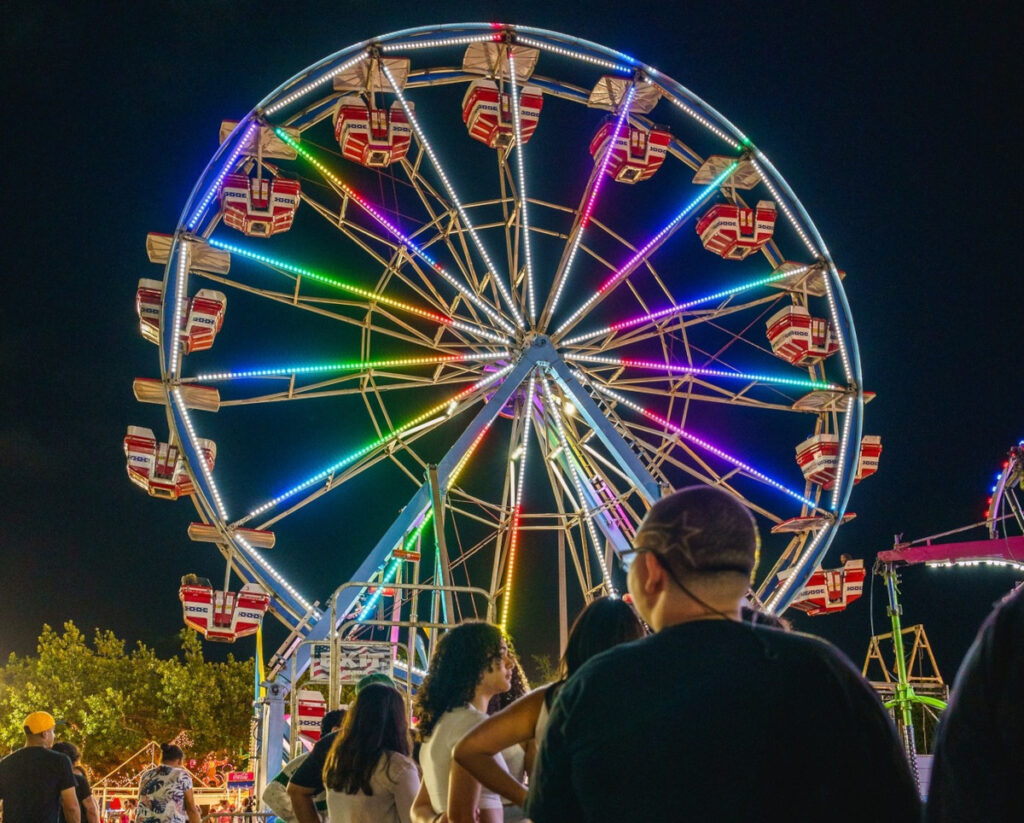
[455,597,644,807]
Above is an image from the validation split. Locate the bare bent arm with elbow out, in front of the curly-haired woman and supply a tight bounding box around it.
[455,687,547,806]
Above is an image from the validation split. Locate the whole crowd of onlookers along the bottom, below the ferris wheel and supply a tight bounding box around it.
[0,486,1024,823]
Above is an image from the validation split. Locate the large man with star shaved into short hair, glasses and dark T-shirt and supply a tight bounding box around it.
[526,486,920,823]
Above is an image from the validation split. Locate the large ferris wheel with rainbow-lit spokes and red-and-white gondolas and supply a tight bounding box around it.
[125,25,882,679]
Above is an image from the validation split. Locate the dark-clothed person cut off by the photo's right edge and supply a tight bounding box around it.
[926,586,1024,823]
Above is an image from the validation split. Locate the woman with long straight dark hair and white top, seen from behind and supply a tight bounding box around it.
[324,683,420,823]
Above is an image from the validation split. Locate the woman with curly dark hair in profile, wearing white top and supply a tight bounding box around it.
[413,622,512,823]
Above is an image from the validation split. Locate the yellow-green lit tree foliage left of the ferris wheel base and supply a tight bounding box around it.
[0,621,253,776]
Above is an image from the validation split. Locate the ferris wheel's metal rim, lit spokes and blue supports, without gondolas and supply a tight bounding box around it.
[140,25,864,778]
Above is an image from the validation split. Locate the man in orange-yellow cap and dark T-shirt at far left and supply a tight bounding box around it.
[0,711,82,823]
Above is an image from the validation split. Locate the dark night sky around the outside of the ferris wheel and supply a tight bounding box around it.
[0,0,1024,680]
